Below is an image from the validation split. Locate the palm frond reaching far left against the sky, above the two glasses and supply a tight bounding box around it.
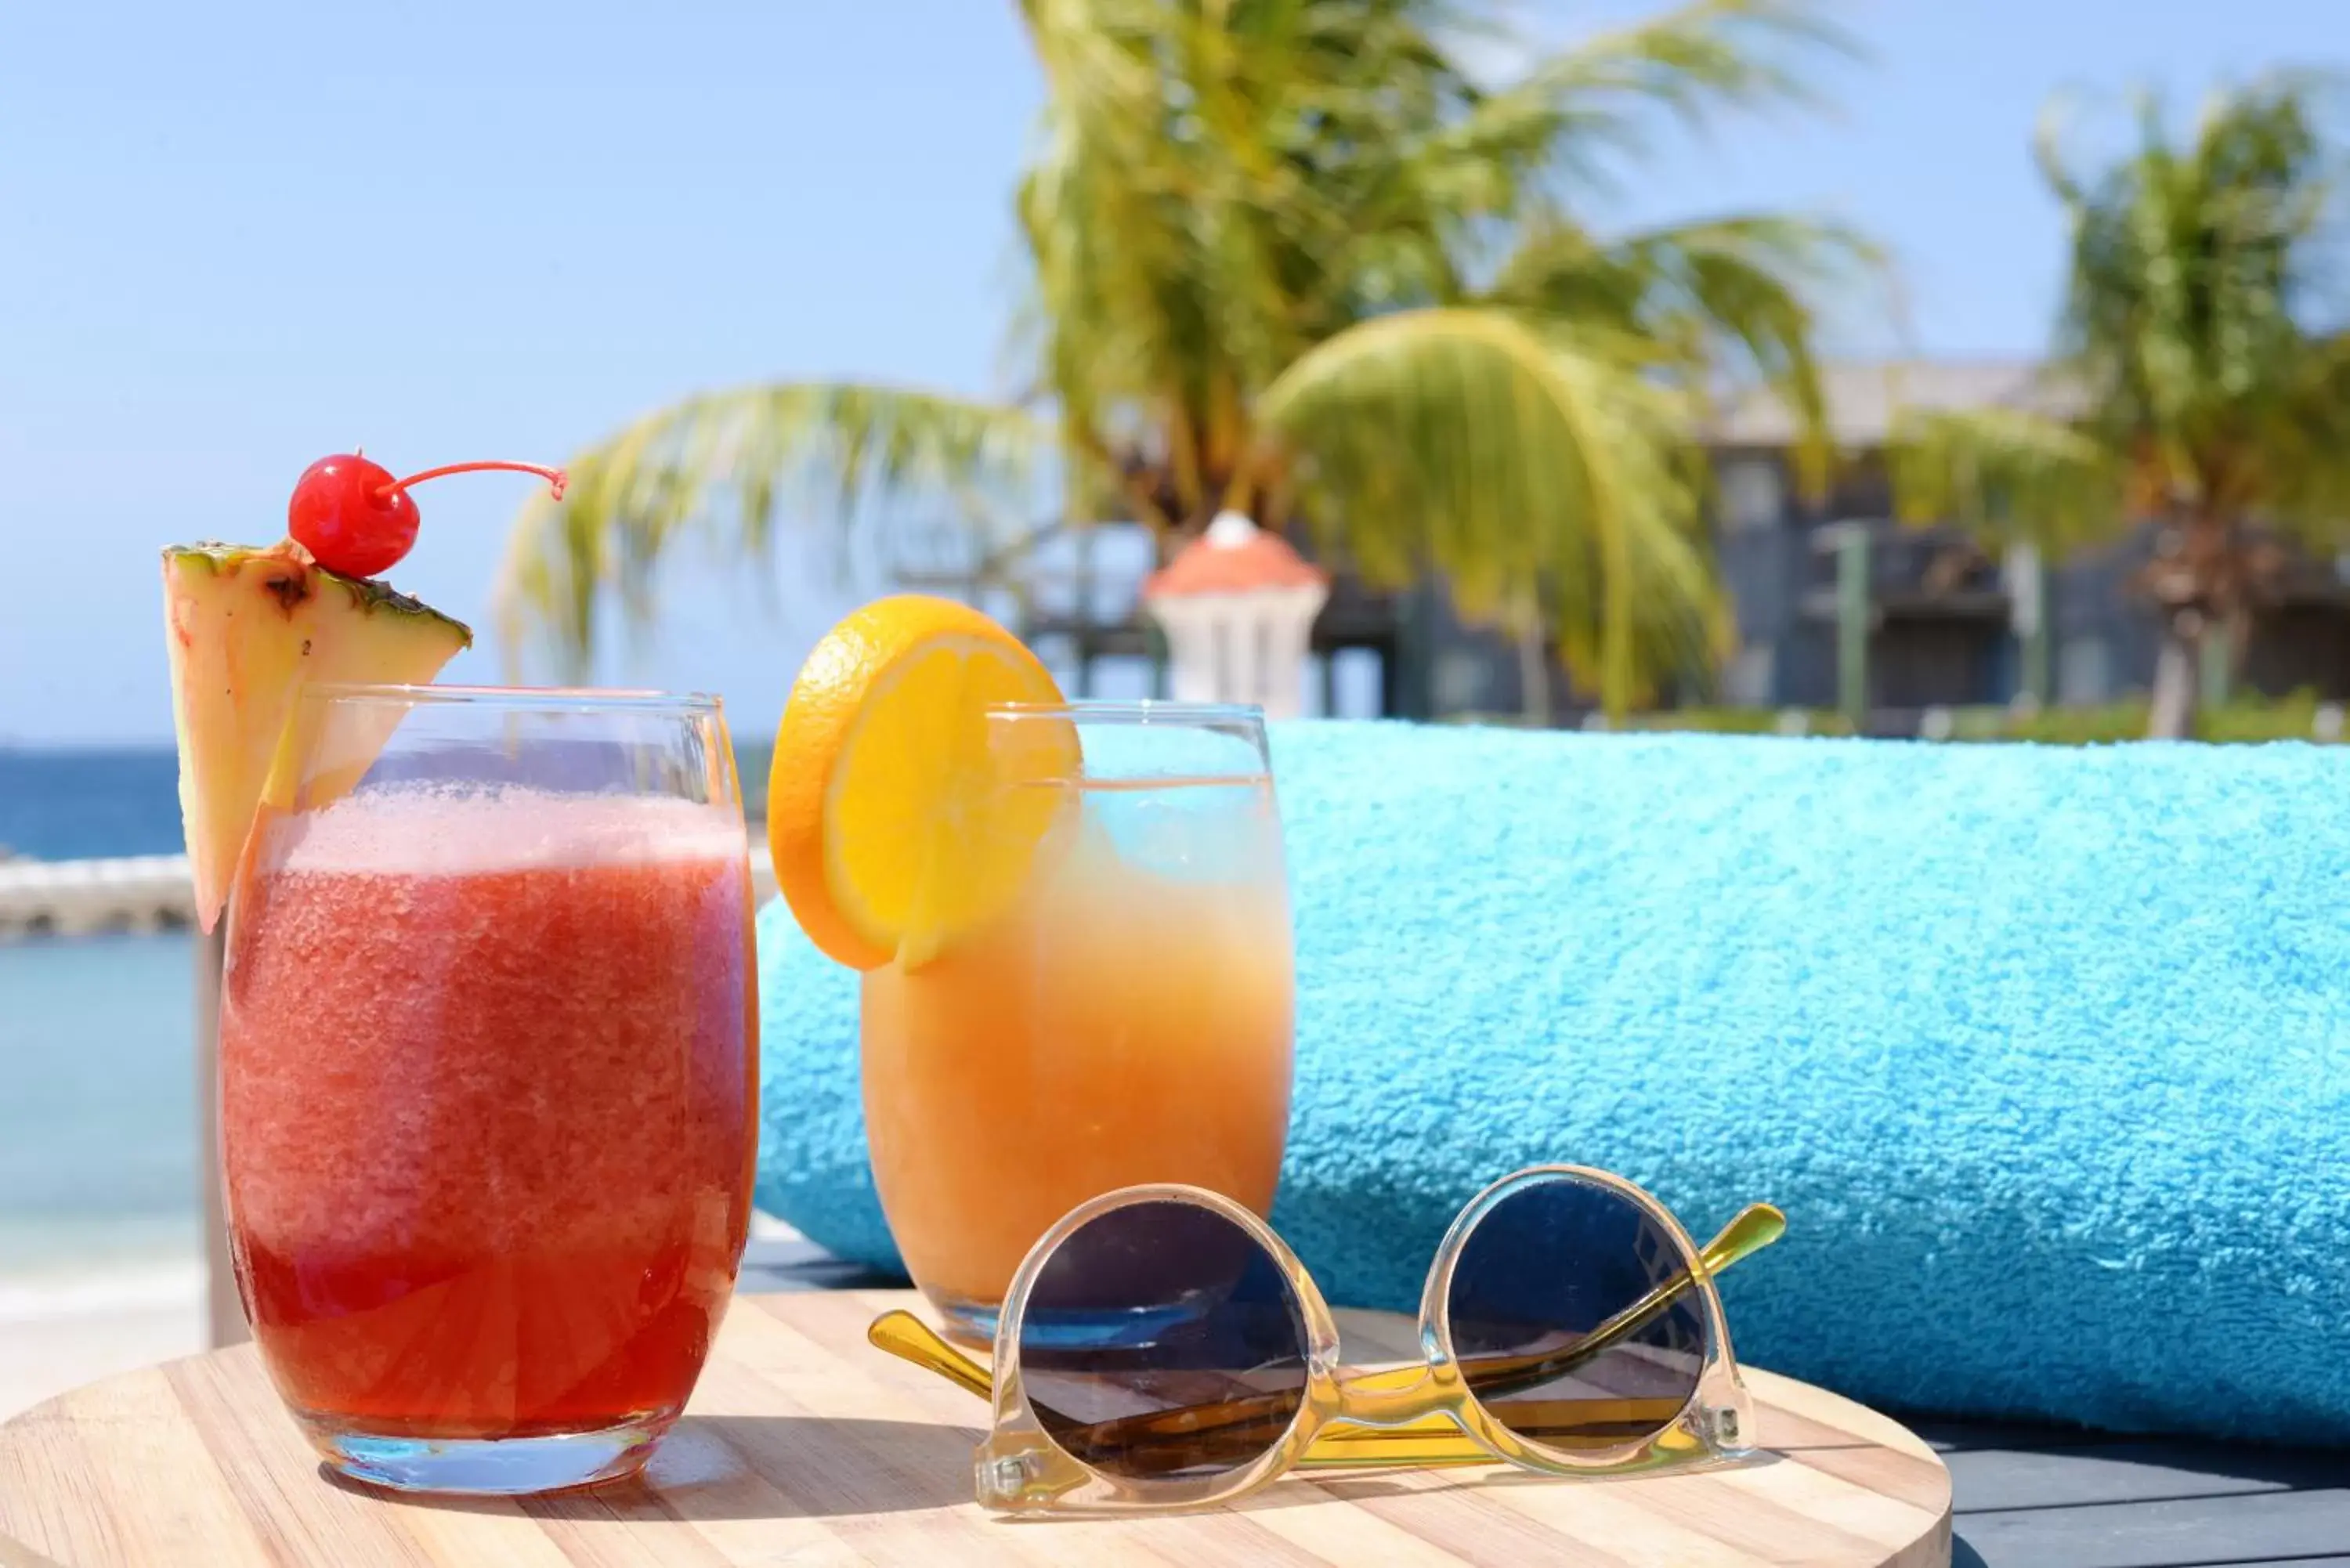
[496,383,1039,674]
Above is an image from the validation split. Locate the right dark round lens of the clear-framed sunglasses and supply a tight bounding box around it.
[1450,1178,1706,1448]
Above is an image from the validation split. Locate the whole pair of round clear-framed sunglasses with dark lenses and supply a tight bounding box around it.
[867,1166,1786,1514]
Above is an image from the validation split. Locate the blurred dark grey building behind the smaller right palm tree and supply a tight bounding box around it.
[1708,359,2350,733]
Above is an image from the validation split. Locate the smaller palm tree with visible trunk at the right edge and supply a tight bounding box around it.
[1894,75,2350,738]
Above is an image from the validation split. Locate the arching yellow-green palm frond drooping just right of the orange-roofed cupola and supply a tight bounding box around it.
[1260,310,1716,712]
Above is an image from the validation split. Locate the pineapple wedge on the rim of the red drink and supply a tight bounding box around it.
[162,540,472,931]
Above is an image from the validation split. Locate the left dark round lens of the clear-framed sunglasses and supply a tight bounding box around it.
[1020,1204,1307,1481]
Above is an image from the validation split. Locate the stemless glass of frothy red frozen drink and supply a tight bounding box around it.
[221,684,759,1493]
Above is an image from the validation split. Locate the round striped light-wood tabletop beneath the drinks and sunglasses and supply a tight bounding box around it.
[0,1291,1950,1568]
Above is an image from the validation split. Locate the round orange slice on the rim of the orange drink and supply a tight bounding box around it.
[766,594,1079,969]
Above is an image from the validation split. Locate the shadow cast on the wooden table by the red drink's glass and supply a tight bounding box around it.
[320,1415,982,1523]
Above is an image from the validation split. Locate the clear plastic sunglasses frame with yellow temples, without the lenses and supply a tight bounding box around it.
[867,1166,1786,1514]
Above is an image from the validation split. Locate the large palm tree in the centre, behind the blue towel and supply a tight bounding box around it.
[501,0,1866,712]
